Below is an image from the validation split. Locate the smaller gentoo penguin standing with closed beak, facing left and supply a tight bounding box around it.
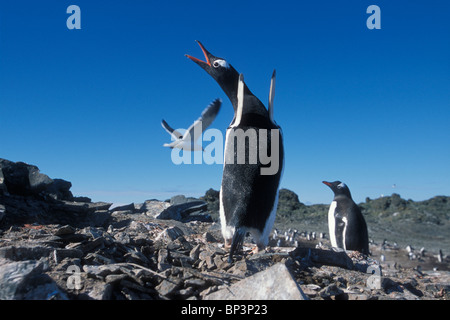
[323,181,369,254]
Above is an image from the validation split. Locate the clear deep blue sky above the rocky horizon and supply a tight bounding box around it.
[0,0,450,203]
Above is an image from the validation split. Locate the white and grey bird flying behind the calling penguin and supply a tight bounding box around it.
[161,99,222,151]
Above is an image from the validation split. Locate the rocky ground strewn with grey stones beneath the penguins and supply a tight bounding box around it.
[0,161,450,300]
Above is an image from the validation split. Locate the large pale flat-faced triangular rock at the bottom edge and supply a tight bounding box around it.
[205,263,308,300]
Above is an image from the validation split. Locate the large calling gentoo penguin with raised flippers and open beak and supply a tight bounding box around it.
[187,42,284,262]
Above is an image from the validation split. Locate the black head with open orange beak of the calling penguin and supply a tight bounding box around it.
[186,41,239,106]
